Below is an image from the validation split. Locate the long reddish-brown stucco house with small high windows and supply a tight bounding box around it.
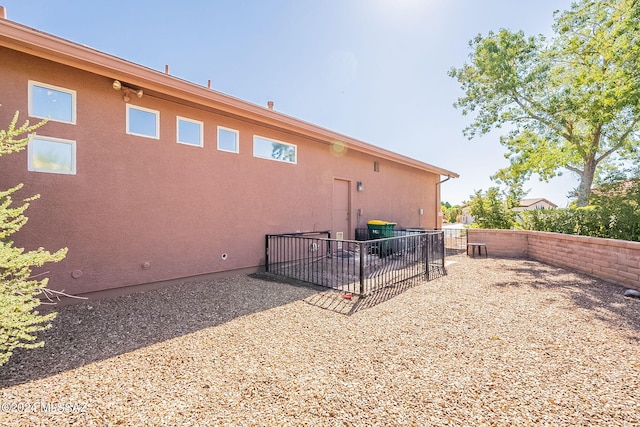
[0,8,458,294]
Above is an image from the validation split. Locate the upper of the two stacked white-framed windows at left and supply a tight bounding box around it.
[29,80,76,124]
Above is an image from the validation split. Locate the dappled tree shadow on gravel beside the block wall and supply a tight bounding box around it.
[494,261,640,341]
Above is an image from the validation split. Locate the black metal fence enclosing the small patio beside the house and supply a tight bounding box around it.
[265,231,446,295]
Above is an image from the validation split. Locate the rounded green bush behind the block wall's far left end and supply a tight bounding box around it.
[469,187,515,229]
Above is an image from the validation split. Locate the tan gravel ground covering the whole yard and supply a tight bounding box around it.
[0,255,640,426]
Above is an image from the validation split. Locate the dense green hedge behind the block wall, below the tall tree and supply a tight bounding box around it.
[521,178,640,241]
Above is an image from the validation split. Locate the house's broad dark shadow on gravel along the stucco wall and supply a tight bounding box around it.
[0,276,324,388]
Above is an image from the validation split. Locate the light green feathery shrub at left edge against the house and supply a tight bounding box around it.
[0,113,67,365]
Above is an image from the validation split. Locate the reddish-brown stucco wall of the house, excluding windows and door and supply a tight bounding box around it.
[0,48,439,294]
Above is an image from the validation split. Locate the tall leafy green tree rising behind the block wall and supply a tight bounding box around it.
[449,0,640,206]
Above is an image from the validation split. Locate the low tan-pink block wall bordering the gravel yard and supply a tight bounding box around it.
[468,229,640,290]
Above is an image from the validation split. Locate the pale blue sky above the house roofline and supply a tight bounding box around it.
[0,0,577,207]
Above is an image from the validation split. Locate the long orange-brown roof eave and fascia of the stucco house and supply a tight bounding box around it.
[0,18,459,178]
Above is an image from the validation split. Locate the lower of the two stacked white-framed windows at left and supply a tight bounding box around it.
[27,135,76,175]
